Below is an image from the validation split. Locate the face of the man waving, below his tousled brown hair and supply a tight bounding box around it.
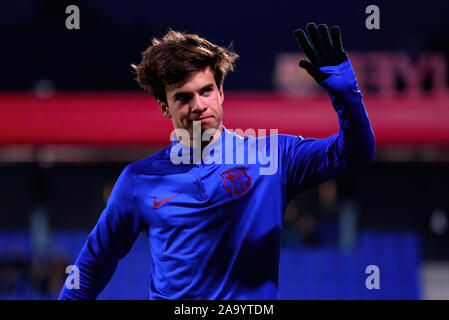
[158,68,223,145]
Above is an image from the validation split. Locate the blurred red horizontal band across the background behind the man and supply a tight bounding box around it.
[0,92,449,146]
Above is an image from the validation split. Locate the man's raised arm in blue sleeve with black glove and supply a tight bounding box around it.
[282,23,375,196]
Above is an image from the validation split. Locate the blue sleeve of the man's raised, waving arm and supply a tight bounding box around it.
[279,59,375,200]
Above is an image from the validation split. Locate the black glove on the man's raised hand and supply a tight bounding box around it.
[293,23,348,82]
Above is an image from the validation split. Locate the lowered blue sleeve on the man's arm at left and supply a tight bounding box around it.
[58,166,143,300]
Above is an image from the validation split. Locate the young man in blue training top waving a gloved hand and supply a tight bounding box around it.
[60,24,374,299]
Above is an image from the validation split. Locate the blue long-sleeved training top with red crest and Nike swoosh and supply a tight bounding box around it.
[59,60,375,299]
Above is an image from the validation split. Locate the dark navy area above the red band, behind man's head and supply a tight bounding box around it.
[0,0,449,90]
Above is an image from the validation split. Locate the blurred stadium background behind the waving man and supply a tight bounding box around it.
[0,0,449,299]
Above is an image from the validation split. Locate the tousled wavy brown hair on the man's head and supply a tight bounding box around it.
[131,30,238,103]
